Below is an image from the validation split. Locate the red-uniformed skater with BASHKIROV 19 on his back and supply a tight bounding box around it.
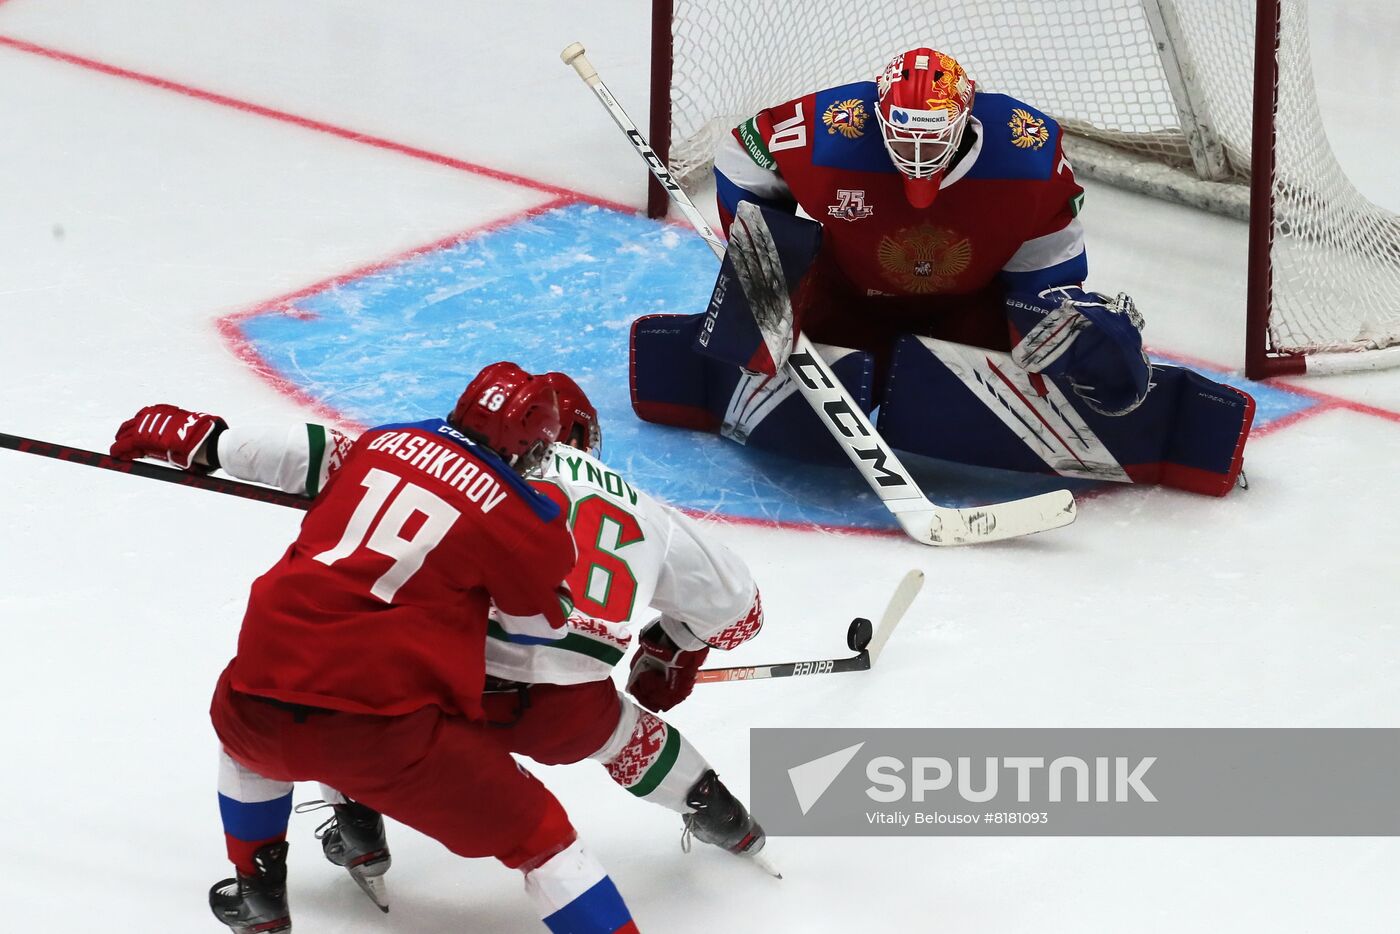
[112,364,637,934]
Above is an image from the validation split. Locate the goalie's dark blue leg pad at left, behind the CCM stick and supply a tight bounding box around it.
[631,315,875,463]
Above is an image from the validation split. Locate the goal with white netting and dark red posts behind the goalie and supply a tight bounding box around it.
[651,0,1400,378]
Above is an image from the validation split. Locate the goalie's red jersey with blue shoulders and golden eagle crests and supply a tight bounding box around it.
[715,81,1086,349]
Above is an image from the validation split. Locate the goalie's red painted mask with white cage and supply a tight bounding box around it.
[875,46,977,207]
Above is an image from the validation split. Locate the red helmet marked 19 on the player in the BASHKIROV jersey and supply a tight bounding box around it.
[448,361,559,475]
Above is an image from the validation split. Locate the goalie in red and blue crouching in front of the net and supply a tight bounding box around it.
[631,46,1253,493]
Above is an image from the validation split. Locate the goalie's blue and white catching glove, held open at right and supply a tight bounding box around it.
[1007,286,1152,416]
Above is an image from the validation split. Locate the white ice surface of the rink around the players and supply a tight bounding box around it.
[0,0,1400,934]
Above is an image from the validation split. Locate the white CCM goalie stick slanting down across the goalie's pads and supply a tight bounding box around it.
[559,42,1075,545]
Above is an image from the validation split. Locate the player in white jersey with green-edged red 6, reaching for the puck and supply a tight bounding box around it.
[117,361,764,907]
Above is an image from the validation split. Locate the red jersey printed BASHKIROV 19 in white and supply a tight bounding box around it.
[230,419,574,717]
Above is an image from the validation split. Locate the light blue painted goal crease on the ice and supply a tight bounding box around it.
[232,204,1315,528]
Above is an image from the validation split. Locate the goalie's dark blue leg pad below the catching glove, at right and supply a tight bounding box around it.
[879,336,1254,496]
